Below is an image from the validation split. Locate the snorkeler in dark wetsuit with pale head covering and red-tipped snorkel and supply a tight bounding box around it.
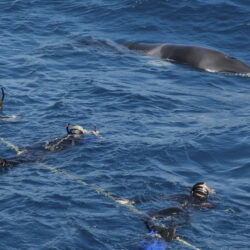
[0,124,99,167]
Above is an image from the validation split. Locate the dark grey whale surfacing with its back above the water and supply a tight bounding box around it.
[123,43,250,73]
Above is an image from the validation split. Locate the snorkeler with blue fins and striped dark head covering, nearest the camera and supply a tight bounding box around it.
[117,182,215,244]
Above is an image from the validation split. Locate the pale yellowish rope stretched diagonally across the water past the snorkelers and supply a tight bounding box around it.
[0,137,201,250]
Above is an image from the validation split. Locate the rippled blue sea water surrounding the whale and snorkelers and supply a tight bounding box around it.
[0,0,250,249]
